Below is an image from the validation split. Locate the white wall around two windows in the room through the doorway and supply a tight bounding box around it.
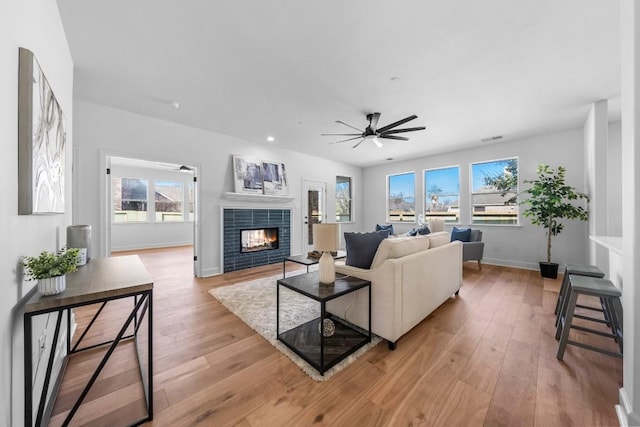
[109,165,193,251]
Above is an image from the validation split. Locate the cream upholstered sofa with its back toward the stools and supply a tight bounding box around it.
[327,231,462,350]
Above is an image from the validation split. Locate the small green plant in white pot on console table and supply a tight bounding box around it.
[23,248,78,295]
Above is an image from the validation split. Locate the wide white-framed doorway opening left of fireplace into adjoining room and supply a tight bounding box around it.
[100,155,201,276]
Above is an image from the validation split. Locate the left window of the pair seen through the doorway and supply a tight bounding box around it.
[112,177,149,222]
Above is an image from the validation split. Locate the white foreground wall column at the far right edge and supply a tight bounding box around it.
[616,0,640,425]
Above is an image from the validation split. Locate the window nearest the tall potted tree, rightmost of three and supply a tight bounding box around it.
[471,158,518,224]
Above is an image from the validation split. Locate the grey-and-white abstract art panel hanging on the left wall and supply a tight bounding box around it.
[18,48,67,215]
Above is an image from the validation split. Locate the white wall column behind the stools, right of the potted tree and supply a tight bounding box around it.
[584,100,609,266]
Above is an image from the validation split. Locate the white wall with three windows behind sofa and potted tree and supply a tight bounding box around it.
[363,128,588,269]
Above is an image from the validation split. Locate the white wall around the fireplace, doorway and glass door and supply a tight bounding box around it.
[74,100,362,276]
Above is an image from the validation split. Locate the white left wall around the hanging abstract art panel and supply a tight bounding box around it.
[0,0,73,426]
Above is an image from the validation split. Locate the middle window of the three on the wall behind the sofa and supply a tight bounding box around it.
[424,166,460,223]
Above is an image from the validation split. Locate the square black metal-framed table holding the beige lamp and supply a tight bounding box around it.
[276,271,371,375]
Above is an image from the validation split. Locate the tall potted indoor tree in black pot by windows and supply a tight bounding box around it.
[522,164,589,279]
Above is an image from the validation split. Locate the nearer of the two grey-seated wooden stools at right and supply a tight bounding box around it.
[556,276,622,360]
